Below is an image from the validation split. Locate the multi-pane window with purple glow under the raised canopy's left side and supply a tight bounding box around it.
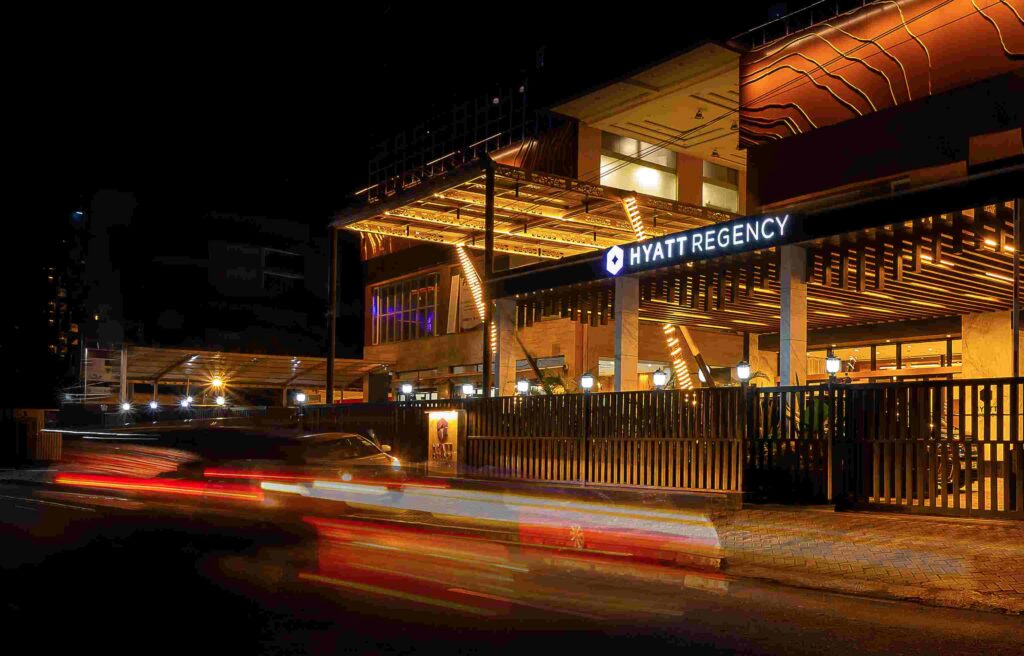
[371,272,440,344]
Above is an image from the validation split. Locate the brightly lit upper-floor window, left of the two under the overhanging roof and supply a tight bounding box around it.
[601,132,679,196]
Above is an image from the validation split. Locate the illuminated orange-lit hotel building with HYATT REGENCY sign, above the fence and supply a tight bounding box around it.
[333,0,1024,398]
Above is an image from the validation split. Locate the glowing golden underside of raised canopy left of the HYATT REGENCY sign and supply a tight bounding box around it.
[346,165,735,259]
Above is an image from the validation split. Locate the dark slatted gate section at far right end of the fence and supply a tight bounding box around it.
[838,379,1024,516]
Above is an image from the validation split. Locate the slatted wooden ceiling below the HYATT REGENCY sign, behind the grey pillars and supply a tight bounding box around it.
[518,203,1015,333]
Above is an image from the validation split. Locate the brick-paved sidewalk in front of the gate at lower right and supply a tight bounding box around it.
[714,507,1024,614]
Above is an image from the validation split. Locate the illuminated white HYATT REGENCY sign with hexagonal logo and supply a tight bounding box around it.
[604,214,803,275]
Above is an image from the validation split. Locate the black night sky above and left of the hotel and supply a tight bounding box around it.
[8,2,786,401]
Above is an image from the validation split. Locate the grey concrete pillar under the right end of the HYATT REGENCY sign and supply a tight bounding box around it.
[778,246,807,385]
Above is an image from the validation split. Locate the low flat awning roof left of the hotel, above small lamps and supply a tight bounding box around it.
[120,346,386,389]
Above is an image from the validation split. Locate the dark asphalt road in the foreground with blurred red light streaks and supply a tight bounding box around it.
[0,484,1024,656]
